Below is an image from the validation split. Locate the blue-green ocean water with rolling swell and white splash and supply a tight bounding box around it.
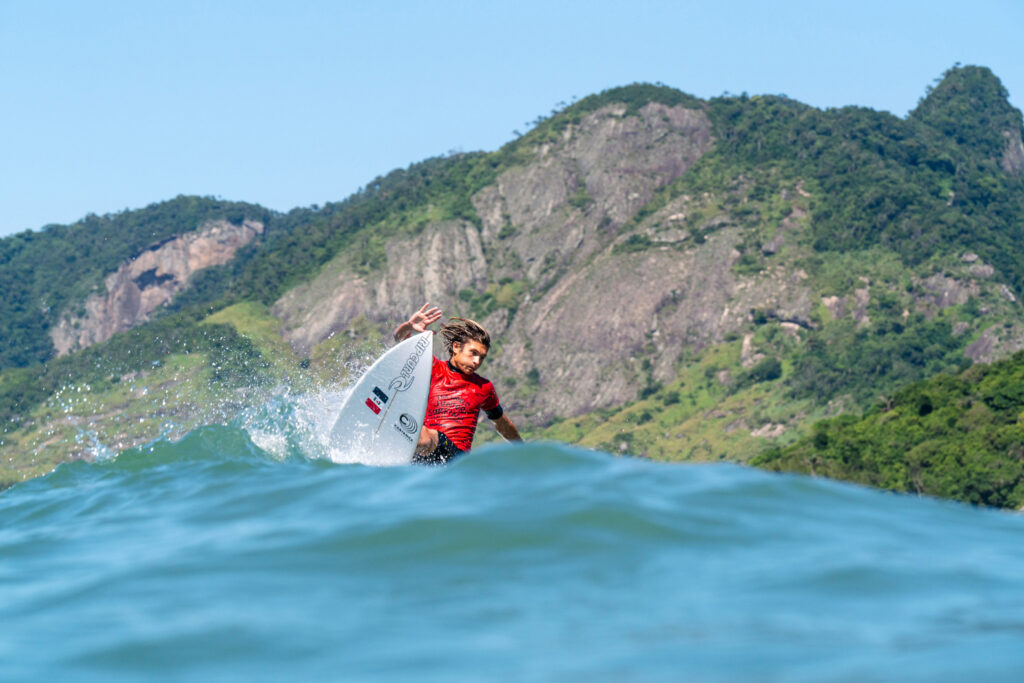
[0,401,1024,681]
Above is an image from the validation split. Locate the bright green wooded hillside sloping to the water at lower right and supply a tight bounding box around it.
[753,352,1024,508]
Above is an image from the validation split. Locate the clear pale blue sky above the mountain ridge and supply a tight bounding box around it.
[0,0,1024,234]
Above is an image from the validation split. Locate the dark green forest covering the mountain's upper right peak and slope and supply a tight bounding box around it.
[710,62,1024,293]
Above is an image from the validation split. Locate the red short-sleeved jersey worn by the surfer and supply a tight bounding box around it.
[423,356,501,451]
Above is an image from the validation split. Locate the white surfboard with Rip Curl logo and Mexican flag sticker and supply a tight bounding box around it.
[331,331,433,465]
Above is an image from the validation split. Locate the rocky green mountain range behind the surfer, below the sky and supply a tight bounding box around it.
[0,67,1024,502]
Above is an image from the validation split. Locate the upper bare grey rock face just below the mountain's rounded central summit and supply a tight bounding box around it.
[472,103,713,280]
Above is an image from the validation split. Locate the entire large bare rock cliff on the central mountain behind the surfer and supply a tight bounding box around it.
[273,103,790,420]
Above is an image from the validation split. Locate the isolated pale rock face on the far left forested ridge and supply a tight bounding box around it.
[50,220,263,355]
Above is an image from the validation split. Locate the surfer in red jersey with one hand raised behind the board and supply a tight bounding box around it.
[394,303,522,465]
